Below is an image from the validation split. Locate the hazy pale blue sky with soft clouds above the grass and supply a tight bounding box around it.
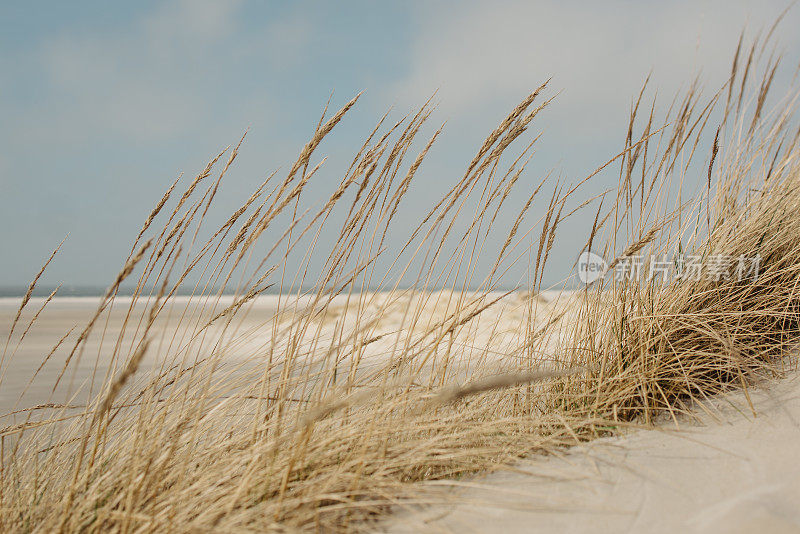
[0,0,800,294]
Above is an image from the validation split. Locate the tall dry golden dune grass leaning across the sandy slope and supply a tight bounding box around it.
[0,31,800,532]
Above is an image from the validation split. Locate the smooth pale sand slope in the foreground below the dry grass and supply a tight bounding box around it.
[387,374,800,533]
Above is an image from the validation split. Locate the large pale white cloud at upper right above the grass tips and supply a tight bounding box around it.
[393,0,797,129]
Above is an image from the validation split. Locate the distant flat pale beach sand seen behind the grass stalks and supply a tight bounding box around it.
[0,292,576,418]
